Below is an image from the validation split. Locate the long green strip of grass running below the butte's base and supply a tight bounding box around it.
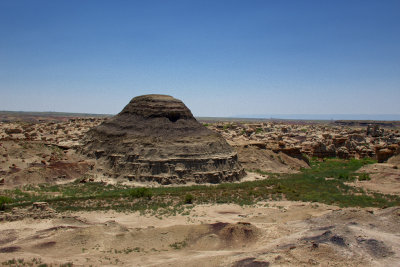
[3,159,400,214]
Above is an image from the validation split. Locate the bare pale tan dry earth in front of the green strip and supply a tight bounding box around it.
[0,201,400,267]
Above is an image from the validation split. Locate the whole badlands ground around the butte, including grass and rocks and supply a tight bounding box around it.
[0,110,400,267]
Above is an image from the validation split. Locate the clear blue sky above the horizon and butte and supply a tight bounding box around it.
[0,0,400,116]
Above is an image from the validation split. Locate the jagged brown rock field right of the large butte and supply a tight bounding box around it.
[207,120,400,162]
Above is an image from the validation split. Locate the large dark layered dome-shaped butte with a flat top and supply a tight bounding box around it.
[83,95,245,184]
